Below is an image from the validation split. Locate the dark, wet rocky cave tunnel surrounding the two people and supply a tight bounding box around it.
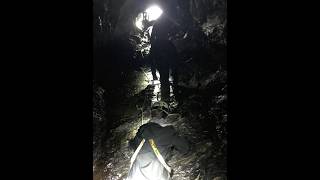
[93,0,228,180]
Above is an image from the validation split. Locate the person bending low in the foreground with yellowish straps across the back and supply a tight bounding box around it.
[126,110,189,180]
